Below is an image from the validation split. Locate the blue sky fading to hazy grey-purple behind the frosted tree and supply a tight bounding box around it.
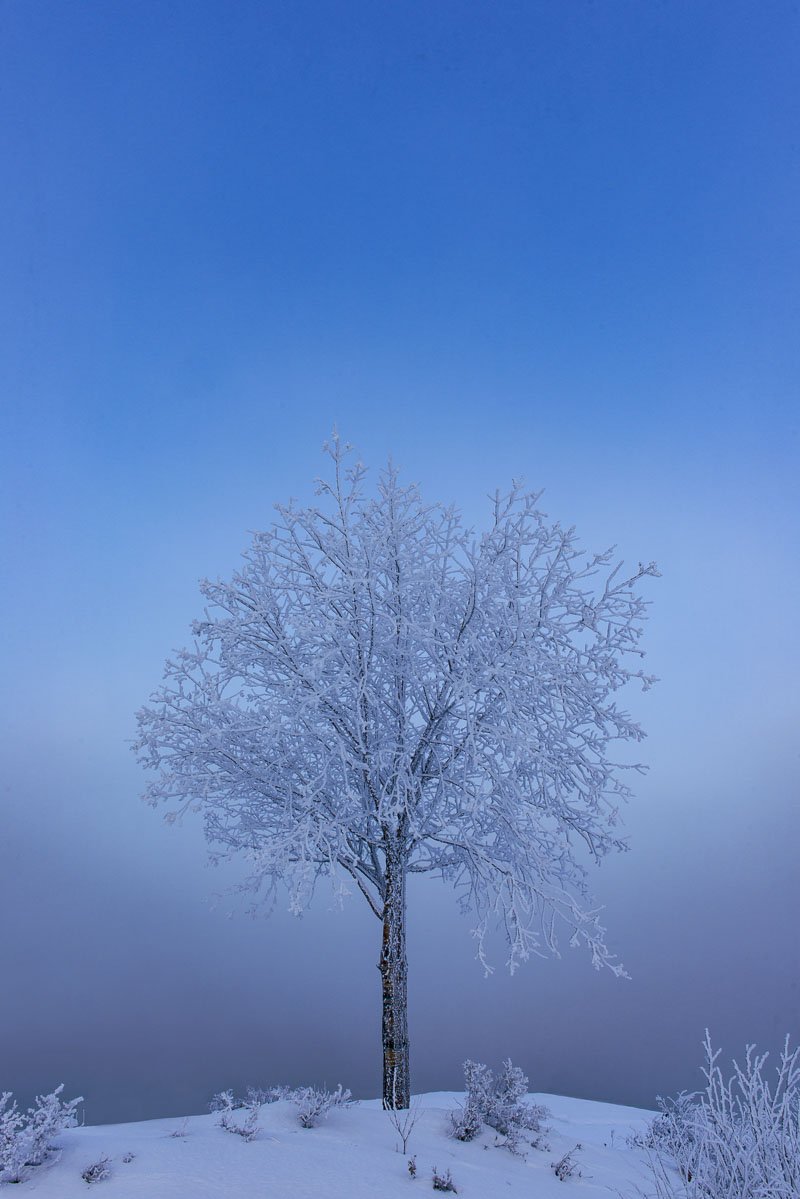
[0,0,800,1123]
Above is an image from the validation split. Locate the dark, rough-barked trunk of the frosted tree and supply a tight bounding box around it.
[379,850,410,1108]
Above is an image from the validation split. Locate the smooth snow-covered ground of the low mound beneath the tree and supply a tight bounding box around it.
[6,1091,652,1199]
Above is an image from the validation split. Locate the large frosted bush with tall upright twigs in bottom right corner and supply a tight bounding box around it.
[640,1030,800,1199]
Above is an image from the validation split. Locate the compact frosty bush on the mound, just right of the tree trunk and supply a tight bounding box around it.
[450,1058,548,1153]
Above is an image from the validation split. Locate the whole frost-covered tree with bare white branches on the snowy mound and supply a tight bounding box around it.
[136,434,657,1108]
